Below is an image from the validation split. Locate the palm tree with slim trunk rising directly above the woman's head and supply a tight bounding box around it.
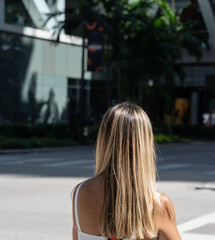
[47,0,153,101]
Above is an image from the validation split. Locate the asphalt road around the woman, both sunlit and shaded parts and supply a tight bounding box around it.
[0,142,215,240]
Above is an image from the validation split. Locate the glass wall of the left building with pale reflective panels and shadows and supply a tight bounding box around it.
[0,32,81,123]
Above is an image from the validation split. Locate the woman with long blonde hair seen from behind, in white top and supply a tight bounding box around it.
[73,102,181,240]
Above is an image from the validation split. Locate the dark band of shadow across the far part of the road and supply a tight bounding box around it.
[0,142,215,183]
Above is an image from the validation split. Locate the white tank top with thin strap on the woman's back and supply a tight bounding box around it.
[74,181,158,240]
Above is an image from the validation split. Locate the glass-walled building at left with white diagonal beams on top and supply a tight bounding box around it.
[0,0,91,123]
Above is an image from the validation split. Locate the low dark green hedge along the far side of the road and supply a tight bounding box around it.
[0,124,215,149]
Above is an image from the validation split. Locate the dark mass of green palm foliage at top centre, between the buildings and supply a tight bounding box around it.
[47,0,206,125]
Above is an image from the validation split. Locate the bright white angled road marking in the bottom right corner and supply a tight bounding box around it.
[178,212,215,240]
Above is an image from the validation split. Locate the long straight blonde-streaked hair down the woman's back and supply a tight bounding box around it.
[95,102,157,239]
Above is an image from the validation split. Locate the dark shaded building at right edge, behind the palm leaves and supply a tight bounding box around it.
[167,0,215,126]
